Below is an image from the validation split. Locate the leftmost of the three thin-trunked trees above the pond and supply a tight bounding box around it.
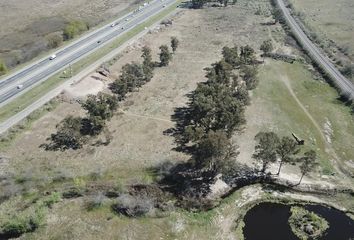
[253,132,279,173]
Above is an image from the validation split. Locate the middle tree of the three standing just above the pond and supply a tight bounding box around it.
[276,137,299,175]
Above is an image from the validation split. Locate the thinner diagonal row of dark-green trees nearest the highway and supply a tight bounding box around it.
[46,37,179,151]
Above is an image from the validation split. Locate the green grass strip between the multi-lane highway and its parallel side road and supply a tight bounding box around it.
[0,1,180,122]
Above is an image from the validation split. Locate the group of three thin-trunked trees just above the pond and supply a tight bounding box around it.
[253,132,317,184]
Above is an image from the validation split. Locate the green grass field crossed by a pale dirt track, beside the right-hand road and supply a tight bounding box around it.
[255,61,354,174]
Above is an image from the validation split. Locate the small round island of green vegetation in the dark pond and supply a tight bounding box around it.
[289,206,329,240]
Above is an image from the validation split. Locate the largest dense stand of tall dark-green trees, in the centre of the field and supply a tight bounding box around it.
[177,46,257,174]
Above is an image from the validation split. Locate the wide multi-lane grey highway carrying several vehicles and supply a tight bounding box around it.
[0,0,176,106]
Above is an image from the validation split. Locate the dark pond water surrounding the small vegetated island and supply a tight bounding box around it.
[243,202,354,240]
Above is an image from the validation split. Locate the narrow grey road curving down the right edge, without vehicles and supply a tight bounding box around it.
[277,0,354,99]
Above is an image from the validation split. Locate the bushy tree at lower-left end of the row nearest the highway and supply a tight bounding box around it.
[44,116,84,151]
